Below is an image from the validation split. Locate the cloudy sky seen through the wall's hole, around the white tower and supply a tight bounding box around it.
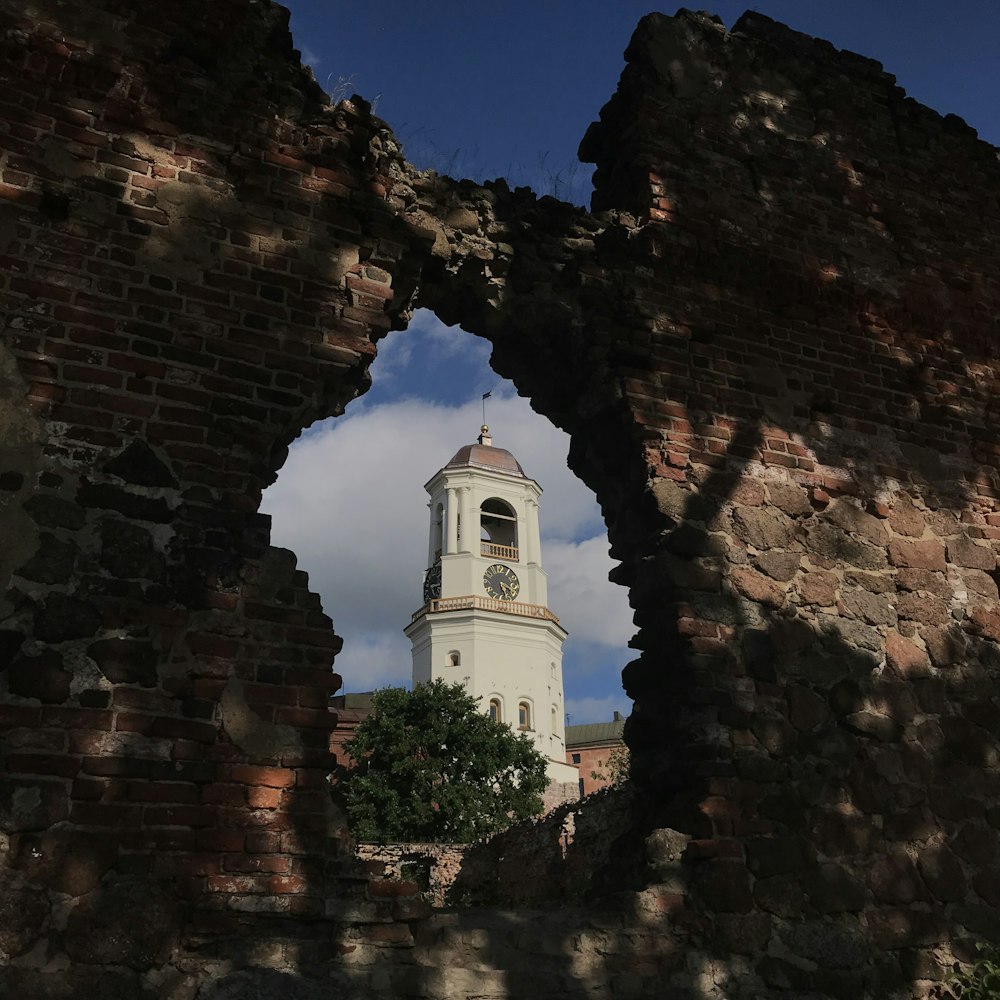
[262,310,634,724]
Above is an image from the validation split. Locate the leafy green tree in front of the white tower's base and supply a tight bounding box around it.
[342,680,548,843]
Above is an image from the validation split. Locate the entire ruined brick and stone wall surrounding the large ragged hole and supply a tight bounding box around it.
[0,0,1000,1000]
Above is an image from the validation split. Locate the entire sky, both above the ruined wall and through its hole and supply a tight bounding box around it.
[263,0,1000,723]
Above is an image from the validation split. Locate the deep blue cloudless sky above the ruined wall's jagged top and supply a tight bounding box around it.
[287,0,1000,195]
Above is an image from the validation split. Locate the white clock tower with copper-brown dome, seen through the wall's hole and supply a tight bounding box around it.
[403,424,579,798]
